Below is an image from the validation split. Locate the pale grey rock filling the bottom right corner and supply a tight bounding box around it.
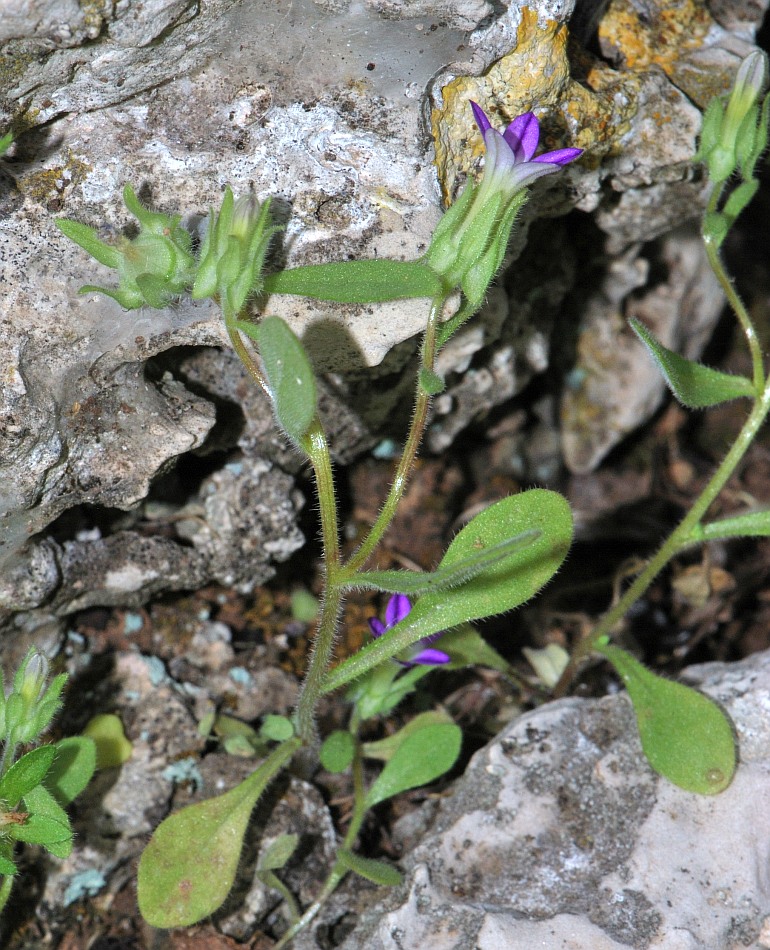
[336,653,770,950]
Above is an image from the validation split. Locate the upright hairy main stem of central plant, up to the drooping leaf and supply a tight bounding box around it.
[297,417,342,745]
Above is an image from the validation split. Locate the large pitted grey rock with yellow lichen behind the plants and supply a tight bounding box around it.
[0,0,762,622]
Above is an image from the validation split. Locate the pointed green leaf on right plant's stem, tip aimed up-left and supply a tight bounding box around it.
[630,320,754,409]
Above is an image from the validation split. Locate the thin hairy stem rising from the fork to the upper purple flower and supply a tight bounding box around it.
[345,297,446,575]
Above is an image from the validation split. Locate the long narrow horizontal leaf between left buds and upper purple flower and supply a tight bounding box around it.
[264,258,442,303]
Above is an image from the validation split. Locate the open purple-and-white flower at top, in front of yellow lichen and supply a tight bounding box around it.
[471,102,583,199]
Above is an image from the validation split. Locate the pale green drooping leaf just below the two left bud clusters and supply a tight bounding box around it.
[236,317,316,443]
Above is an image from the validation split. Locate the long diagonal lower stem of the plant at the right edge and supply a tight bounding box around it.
[554,372,770,697]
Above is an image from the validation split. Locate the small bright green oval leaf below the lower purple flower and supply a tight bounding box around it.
[366,723,462,808]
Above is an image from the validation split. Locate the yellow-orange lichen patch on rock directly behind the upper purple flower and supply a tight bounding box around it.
[431,7,638,202]
